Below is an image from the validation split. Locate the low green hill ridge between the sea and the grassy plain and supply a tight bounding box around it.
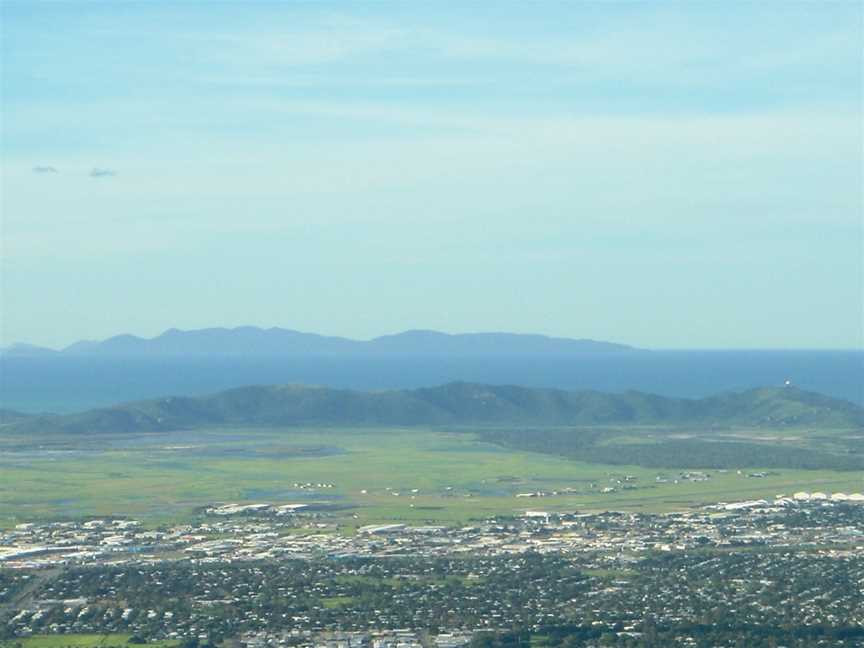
[0,383,864,435]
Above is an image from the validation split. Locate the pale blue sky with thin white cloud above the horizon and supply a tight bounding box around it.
[0,0,864,349]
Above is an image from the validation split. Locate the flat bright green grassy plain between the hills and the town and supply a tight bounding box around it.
[0,428,864,526]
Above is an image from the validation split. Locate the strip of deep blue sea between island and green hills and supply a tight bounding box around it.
[0,351,864,413]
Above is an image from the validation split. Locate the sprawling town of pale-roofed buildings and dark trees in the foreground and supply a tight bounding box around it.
[0,493,864,648]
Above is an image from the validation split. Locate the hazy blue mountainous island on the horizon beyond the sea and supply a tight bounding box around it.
[2,326,633,357]
